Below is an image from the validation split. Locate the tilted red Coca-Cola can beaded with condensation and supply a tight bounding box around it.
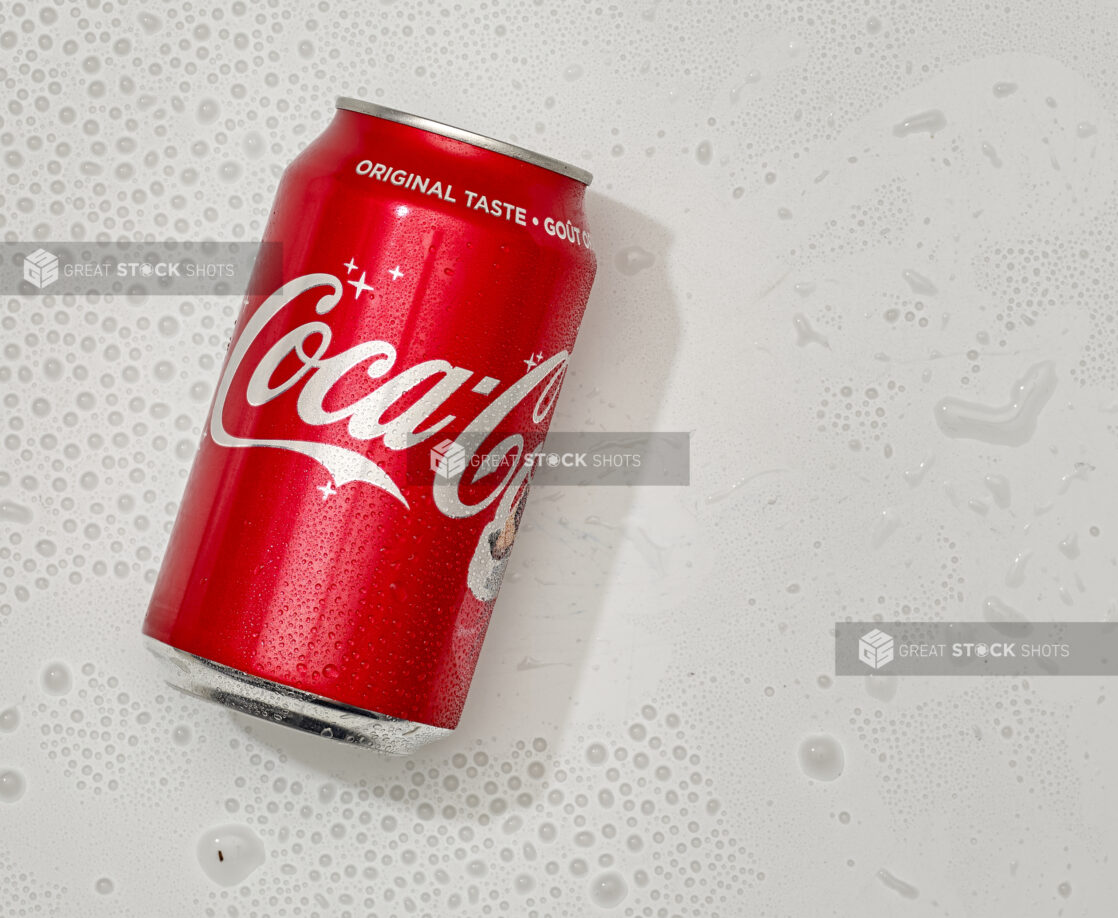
[143,98,595,753]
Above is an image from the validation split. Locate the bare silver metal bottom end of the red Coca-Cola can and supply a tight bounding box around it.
[144,635,453,756]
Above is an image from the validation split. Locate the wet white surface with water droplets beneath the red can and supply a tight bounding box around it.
[0,0,1118,918]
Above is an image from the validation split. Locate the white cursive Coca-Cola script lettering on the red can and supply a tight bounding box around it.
[209,274,569,518]
